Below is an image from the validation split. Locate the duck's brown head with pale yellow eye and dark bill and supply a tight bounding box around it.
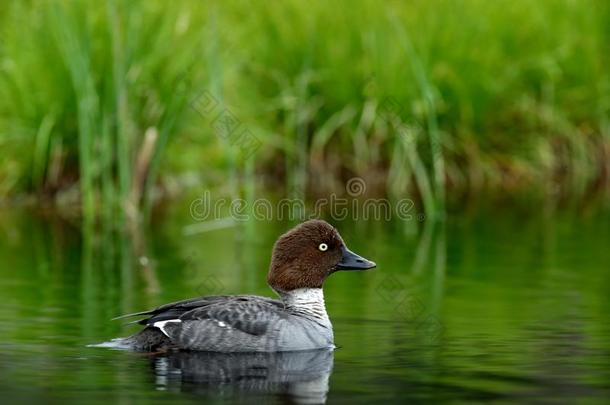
[267,219,376,292]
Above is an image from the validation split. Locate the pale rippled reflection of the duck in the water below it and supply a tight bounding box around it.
[152,349,333,404]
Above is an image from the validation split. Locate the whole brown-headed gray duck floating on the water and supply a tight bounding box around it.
[113,219,376,353]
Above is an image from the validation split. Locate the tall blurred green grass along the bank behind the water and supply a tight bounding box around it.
[0,0,610,220]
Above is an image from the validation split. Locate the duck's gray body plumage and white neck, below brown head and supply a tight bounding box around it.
[121,289,334,352]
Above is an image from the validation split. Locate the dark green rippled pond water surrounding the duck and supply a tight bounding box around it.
[0,203,610,404]
